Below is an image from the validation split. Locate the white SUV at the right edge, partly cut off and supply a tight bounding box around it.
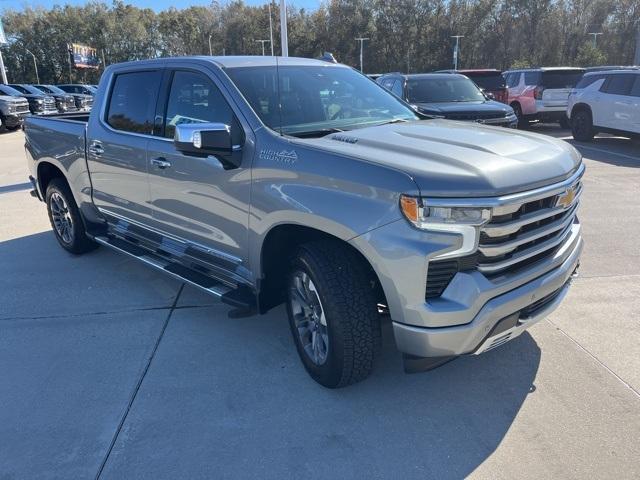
[567,70,640,142]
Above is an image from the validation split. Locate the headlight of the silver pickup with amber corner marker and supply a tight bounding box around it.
[400,195,491,259]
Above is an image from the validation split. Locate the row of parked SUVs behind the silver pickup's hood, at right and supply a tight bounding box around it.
[378,66,640,140]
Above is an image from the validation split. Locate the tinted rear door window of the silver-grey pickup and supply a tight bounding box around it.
[107,70,162,135]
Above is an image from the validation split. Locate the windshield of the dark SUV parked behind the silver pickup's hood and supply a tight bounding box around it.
[407,74,486,103]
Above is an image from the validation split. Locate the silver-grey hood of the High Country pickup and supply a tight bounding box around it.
[294,119,582,197]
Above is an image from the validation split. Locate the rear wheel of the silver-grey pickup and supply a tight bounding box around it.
[45,178,98,255]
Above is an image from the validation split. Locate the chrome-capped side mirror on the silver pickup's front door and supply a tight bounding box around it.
[173,123,234,156]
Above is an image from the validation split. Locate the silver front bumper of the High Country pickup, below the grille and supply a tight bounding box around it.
[393,236,583,357]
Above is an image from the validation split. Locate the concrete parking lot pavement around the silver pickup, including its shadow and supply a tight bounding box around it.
[0,125,640,479]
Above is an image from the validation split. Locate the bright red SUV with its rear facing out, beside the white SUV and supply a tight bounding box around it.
[503,67,584,128]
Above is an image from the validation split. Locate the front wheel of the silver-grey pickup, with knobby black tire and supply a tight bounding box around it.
[287,241,381,388]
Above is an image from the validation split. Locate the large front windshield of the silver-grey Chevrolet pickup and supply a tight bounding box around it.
[226,65,418,135]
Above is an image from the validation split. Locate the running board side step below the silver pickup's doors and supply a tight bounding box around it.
[93,236,257,317]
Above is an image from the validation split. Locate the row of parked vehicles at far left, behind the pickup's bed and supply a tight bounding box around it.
[0,84,96,130]
